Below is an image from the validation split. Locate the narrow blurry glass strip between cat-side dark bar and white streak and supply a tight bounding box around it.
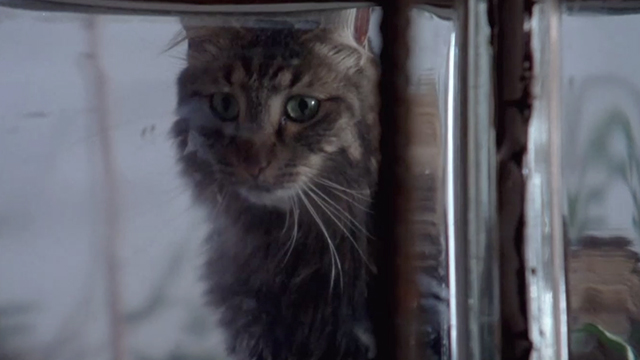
[408,10,455,359]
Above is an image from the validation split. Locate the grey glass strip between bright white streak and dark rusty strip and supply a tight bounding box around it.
[465,0,501,360]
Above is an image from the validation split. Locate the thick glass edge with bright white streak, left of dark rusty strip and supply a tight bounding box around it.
[445,0,501,360]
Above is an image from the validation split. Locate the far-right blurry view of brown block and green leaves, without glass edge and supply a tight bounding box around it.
[562,7,640,359]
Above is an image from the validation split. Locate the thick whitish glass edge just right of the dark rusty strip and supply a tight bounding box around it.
[524,0,569,360]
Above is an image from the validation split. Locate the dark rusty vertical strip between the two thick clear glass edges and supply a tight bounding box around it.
[490,0,534,360]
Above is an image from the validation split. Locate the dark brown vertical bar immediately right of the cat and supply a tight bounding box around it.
[371,0,418,360]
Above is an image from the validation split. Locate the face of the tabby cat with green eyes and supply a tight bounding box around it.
[173,28,377,205]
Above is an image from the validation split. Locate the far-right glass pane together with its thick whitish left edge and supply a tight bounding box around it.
[527,1,640,359]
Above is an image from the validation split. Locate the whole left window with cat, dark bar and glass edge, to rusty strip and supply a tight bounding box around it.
[0,0,501,360]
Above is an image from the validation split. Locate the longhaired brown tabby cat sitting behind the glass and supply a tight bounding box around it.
[172,10,379,360]
